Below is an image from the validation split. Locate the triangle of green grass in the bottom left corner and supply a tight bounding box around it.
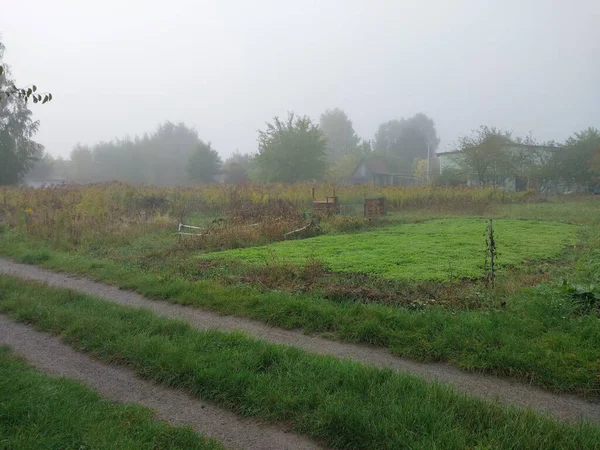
[0,346,222,450]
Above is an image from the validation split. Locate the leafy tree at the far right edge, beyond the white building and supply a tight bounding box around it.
[557,128,600,191]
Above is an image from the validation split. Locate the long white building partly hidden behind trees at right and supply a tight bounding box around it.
[436,143,561,192]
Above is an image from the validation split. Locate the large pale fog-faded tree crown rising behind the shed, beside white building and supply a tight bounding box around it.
[374,113,440,164]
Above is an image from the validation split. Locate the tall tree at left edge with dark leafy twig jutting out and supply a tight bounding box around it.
[0,43,51,185]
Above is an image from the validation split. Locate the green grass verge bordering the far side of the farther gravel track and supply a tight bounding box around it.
[0,231,600,396]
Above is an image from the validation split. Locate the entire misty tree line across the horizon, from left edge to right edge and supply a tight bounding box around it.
[0,42,600,190]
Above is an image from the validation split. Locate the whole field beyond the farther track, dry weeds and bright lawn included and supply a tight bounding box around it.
[0,184,600,397]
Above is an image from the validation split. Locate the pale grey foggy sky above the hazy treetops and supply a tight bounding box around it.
[0,0,600,157]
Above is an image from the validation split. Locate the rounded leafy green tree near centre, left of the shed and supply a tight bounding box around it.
[256,113,327,183]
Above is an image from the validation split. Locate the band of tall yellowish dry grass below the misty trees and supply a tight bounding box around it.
[0,182,533,243]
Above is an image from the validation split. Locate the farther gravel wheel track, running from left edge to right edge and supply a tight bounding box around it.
[0,259,600,423]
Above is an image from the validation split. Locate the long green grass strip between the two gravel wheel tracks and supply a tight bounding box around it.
[0,276,600,449]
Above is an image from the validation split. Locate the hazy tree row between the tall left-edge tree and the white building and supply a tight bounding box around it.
[11,109,439,185]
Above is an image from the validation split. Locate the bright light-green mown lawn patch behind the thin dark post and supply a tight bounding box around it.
[200,219,578,281]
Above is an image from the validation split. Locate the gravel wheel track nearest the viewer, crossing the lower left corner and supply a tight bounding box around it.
[0,315,321,450]
